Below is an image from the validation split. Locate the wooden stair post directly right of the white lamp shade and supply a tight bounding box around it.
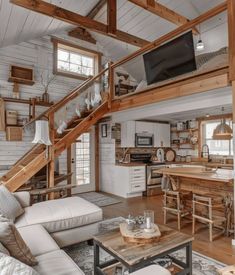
[47,112,55,200]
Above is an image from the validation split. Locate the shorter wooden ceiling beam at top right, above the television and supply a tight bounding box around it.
[128,0,199,34]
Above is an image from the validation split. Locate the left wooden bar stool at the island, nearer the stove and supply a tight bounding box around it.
[163,190,192,231]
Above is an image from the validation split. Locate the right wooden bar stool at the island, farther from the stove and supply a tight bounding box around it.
[192,194,226,242]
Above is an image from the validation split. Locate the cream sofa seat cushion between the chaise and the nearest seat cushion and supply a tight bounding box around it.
[18,224,60,256]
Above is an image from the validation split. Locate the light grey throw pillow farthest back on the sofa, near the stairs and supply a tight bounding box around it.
[0,185,24,221]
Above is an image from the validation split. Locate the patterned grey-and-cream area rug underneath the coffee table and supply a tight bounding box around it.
[64,217,225,275]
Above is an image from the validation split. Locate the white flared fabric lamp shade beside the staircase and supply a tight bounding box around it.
[32,120,52,145]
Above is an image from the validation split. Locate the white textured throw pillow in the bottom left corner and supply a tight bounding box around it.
[0,252,39,275]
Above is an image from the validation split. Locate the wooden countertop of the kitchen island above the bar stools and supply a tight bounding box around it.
[158,166,233,183]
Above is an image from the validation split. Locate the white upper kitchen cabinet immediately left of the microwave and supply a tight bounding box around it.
[121,121,136,147]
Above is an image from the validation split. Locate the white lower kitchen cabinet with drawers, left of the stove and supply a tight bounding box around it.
[101,165,146,198]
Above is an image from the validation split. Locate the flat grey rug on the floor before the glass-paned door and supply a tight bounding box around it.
[77,192,121,207]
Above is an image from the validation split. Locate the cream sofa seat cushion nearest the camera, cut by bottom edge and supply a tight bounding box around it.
[34,250,84,275]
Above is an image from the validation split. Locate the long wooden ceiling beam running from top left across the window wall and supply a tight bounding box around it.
[10,0,150,47]
